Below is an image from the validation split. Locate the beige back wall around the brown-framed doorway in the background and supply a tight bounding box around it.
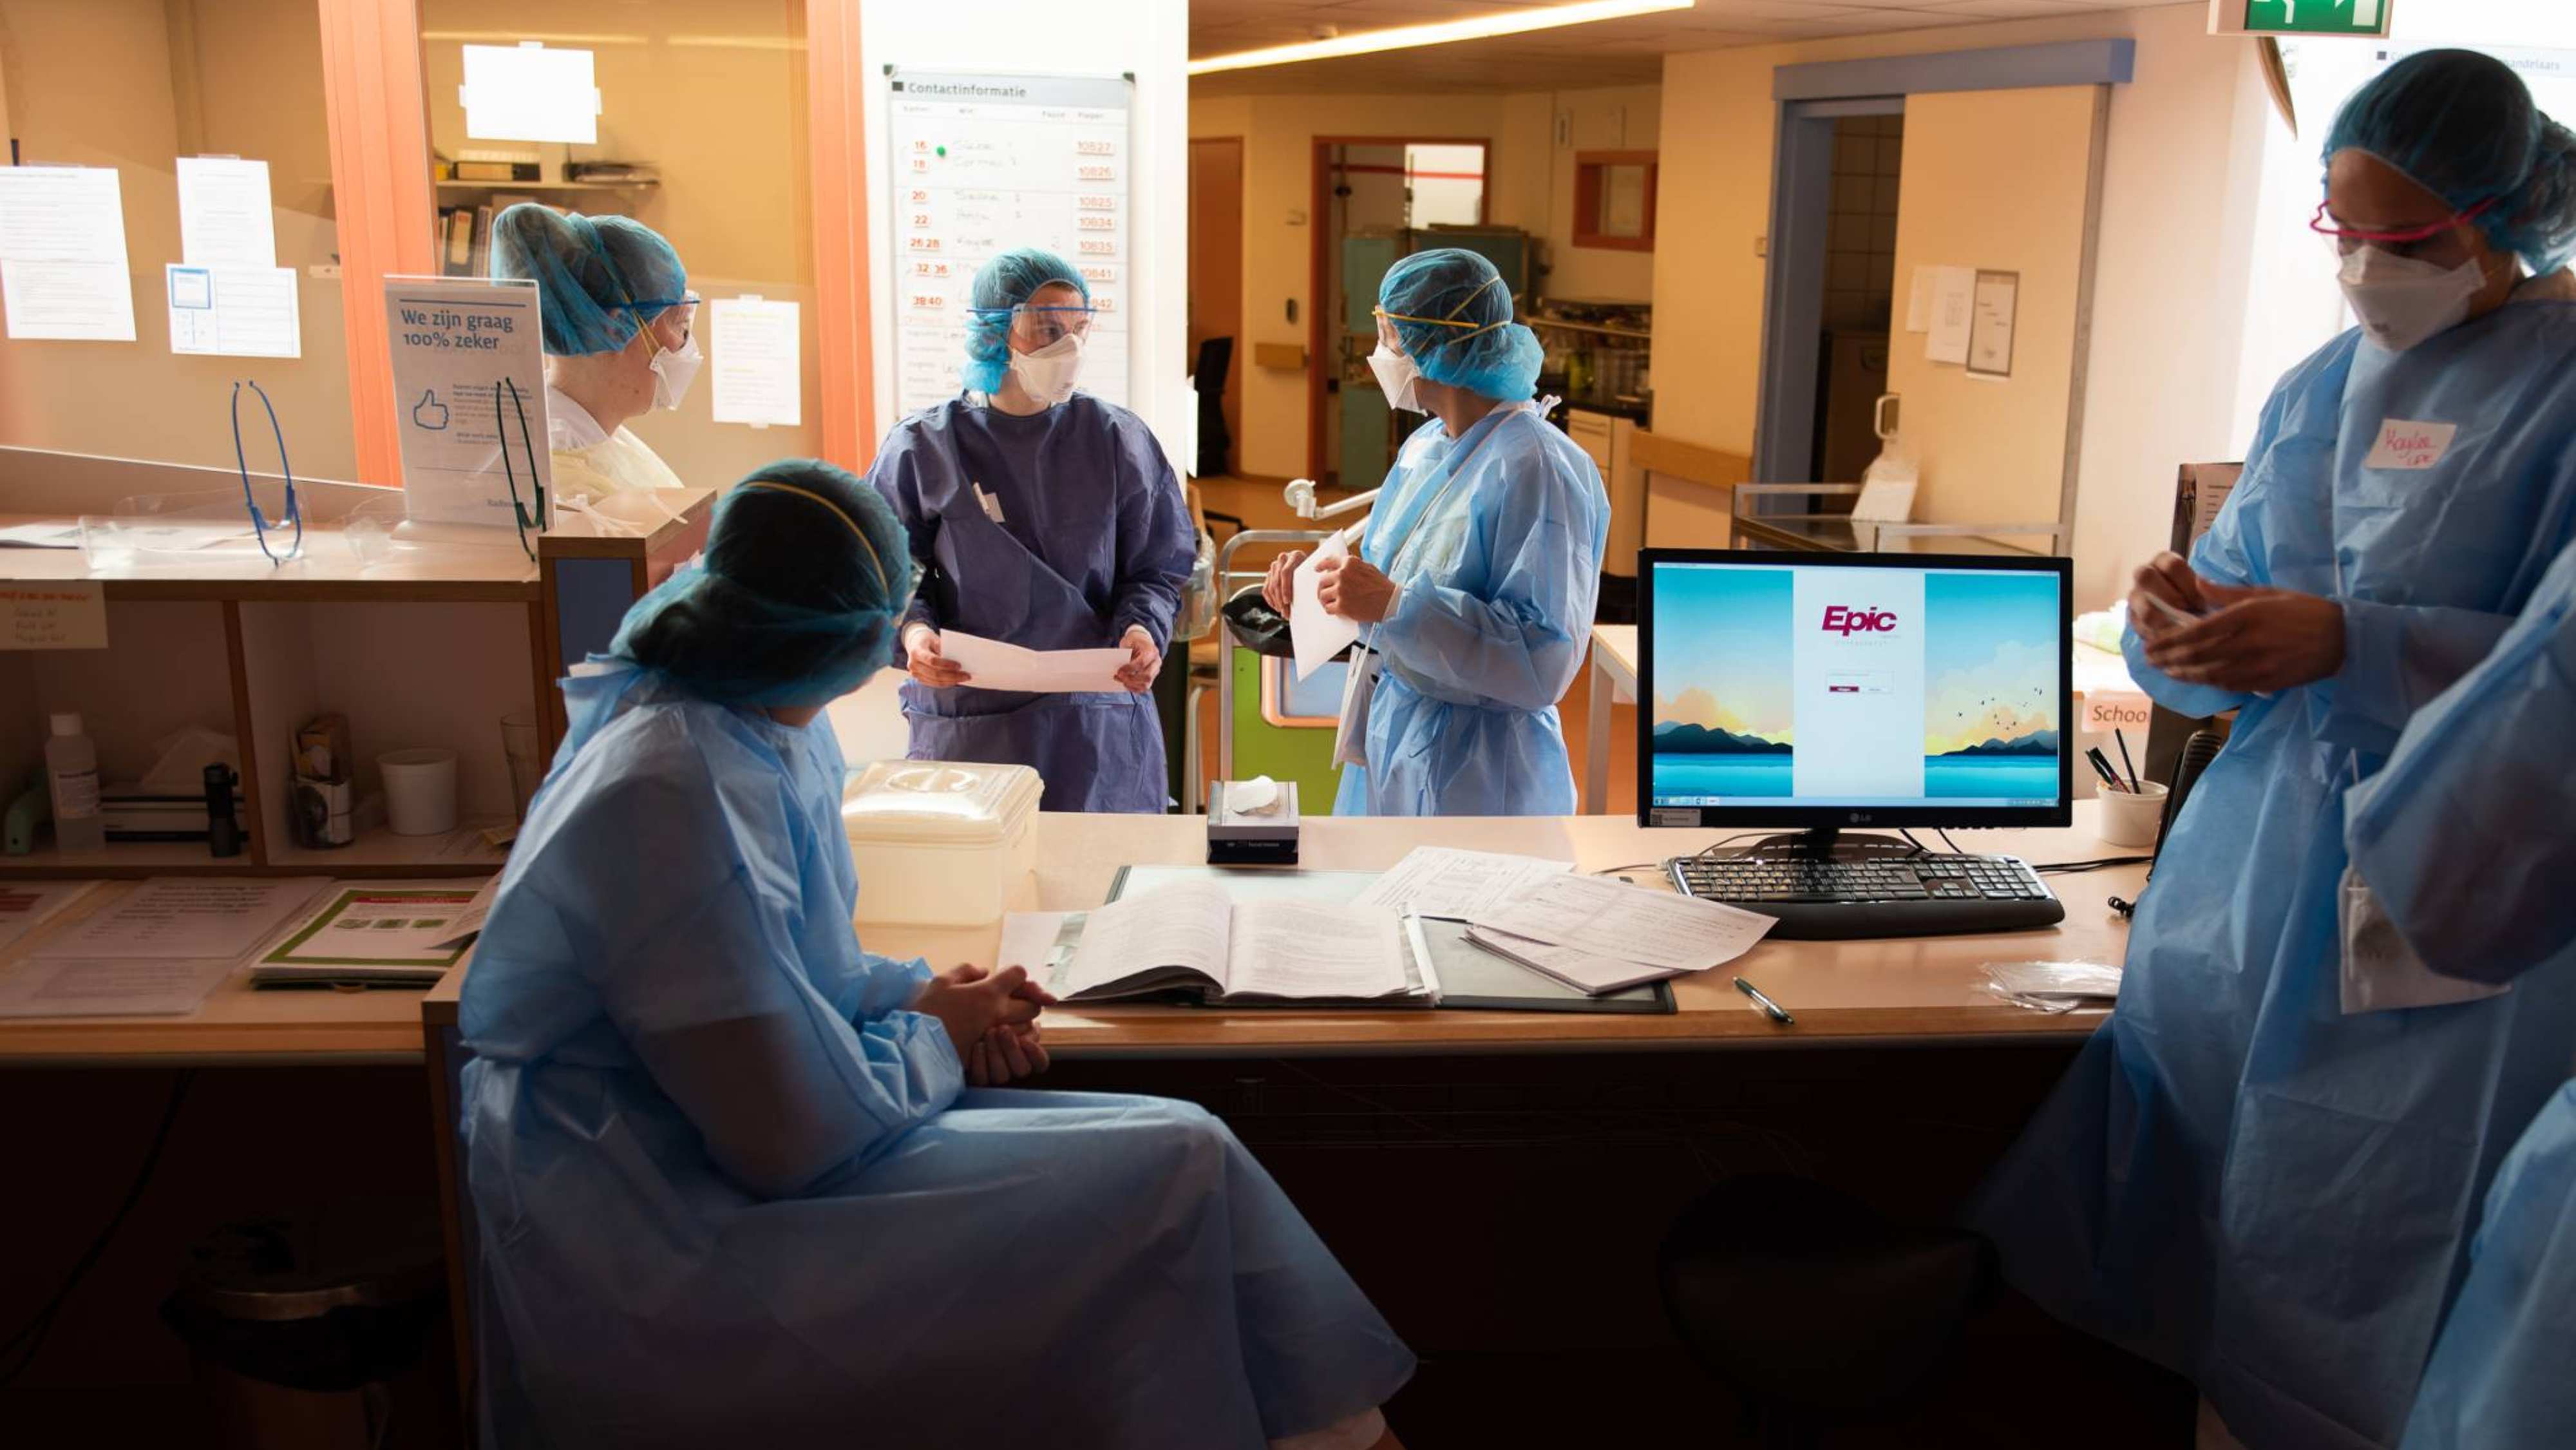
[1190,85,1662,477]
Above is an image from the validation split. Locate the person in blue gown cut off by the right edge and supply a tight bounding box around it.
[2344,549,2576,1450]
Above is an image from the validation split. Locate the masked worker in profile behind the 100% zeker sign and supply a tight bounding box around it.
[492,201,703,504]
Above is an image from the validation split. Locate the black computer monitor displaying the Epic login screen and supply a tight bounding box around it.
[1636,549,2074,832]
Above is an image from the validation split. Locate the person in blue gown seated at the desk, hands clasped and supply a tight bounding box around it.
[461,464,1414,1450]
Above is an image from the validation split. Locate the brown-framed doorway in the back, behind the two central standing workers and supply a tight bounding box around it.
[1306,137,1492,490]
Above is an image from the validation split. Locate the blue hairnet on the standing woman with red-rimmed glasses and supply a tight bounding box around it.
[2326,52,2576,276]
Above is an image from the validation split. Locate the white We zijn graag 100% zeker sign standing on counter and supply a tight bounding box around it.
[384,276,554,533]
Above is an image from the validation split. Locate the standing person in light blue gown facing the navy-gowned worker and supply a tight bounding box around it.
[1262,247,1610,816]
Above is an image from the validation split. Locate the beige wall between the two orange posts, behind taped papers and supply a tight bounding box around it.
[420,0,822,487]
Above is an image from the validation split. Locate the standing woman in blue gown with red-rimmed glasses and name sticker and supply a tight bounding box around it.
[1973,52,2576,1450]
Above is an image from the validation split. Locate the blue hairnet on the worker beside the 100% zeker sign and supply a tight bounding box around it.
[492,201,688,358]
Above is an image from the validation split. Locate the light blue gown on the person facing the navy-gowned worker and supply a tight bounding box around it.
[1332,405,1610,816]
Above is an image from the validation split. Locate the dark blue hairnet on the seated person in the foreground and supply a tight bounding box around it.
[608,459,912,706]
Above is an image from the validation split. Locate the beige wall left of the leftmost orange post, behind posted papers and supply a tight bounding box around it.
[0,0,358,479]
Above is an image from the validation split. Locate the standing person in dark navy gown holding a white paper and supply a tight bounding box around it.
[868,250,1195,814]
